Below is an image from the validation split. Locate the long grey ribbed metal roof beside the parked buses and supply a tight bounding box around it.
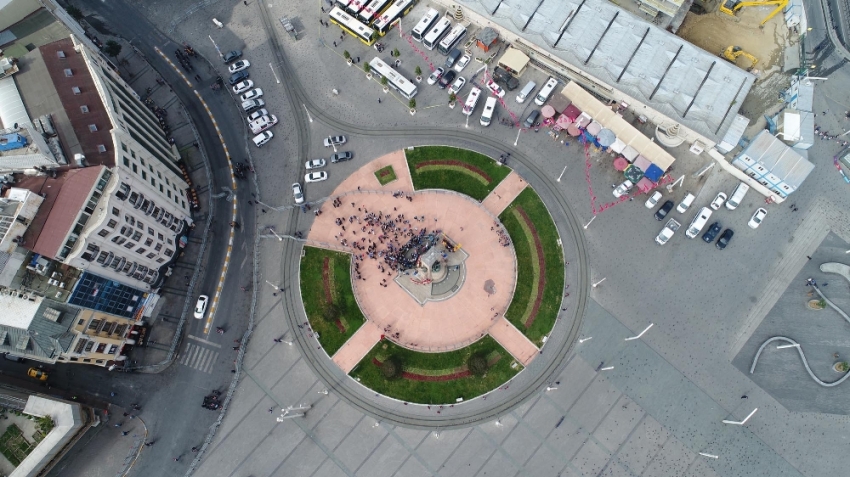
[459,0,755,141]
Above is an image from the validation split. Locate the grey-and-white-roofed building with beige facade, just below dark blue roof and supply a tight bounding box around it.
[0,289,140,367]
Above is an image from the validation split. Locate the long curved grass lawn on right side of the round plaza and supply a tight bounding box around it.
[499,188,564,346]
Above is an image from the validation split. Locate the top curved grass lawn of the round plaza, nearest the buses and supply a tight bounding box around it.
[404,146,511,201]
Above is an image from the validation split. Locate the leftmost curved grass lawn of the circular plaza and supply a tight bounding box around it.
[301,247,366,356]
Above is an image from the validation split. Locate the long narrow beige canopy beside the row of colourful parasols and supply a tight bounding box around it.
[561,81,676,171]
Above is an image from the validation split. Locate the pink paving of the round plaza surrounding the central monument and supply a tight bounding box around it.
[308,152,536,372]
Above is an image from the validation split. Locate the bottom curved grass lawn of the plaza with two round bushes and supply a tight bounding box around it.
[350,335,522,404]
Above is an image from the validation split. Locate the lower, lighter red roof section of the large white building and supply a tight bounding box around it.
[15,166,104,258]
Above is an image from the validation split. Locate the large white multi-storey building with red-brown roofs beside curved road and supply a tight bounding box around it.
[0,36,192,292]
